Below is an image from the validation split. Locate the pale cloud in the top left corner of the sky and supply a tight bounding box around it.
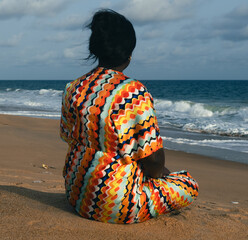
[0,0,75,19]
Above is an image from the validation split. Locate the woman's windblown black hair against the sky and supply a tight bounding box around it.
[86,9,136,67]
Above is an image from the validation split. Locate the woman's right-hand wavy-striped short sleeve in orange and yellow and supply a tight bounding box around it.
[111,81,163,164]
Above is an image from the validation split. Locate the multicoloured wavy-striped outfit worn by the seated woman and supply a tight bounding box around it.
[60,67,198,223]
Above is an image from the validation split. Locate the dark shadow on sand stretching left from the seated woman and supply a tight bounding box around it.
[0,185,76,214]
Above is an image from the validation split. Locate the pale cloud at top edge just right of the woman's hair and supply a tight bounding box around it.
[119,0,196,25]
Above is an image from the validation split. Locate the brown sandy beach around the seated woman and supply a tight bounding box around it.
[0,115,248,240]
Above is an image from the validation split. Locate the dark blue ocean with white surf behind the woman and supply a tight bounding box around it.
[0,80,248,164]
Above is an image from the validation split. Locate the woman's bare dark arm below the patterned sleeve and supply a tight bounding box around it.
[139,148,170,178]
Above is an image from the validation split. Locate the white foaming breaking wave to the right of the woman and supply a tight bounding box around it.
[155,99,248,137]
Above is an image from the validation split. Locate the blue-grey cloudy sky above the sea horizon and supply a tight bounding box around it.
[0,0,248,80]
